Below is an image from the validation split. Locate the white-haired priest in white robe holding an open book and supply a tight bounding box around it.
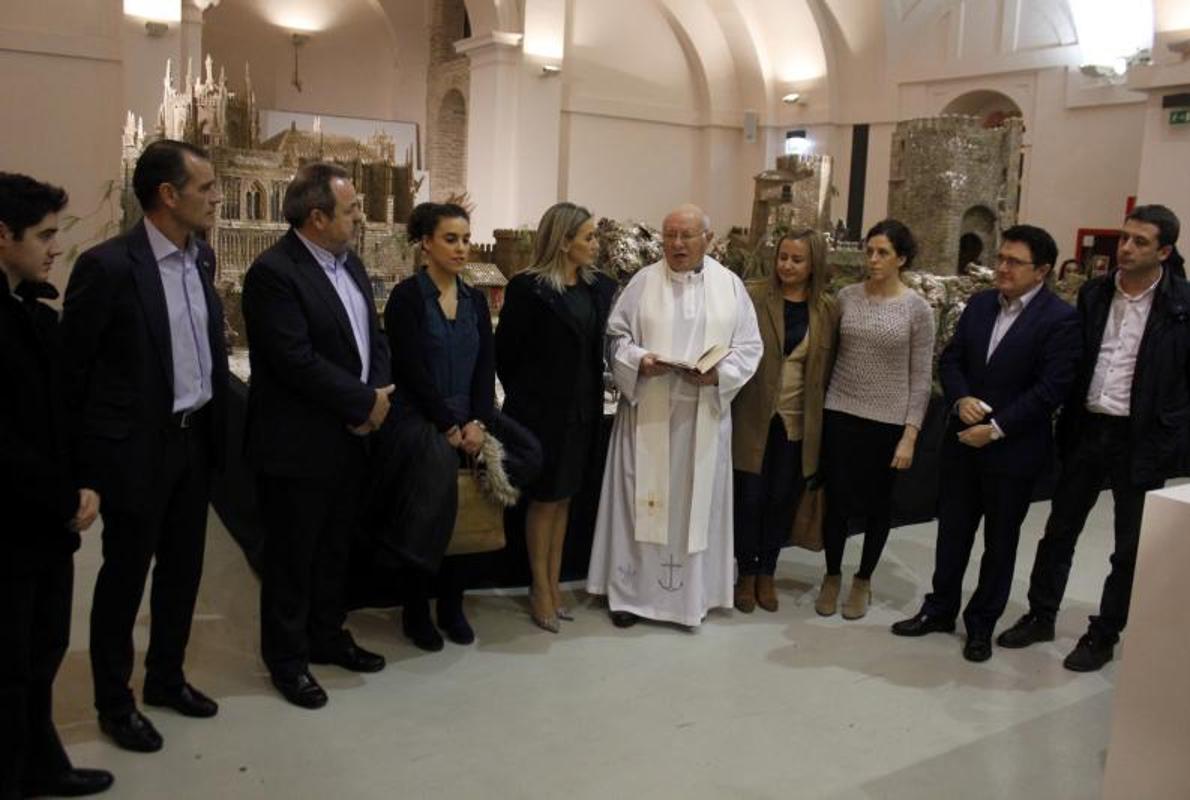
[587,206,763,627]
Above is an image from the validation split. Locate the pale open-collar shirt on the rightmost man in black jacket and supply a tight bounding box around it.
[1086,270,1165,417]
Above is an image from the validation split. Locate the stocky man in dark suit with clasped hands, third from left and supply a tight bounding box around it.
[243,163,393,708]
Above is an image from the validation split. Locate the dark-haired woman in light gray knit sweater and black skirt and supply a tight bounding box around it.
[814,219,934,619]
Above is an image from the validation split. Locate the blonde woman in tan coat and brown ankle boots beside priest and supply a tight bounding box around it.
[732,229,837,613]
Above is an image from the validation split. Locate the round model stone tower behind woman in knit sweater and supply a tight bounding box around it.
[889,115,1023,275]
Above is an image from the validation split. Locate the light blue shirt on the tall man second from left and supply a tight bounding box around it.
[145,218,213,412]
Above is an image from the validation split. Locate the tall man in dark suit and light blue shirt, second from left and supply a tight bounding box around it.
[62,139,227,752]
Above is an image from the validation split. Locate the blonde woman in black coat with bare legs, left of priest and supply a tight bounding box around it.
[496,202,616,633]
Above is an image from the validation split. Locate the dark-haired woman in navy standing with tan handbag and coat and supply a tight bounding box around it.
[372,202,495,651]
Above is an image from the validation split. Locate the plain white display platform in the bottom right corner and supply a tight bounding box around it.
[1103,485,1190,800]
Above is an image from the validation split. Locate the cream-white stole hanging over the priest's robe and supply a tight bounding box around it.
[634,256,739,552]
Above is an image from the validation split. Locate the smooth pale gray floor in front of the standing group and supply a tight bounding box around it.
[57,483,1156,800]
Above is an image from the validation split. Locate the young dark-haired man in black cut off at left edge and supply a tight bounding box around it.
[0,173,112,800]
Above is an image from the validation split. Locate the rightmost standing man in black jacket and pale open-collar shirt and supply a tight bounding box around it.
[997,205,1190,673]
